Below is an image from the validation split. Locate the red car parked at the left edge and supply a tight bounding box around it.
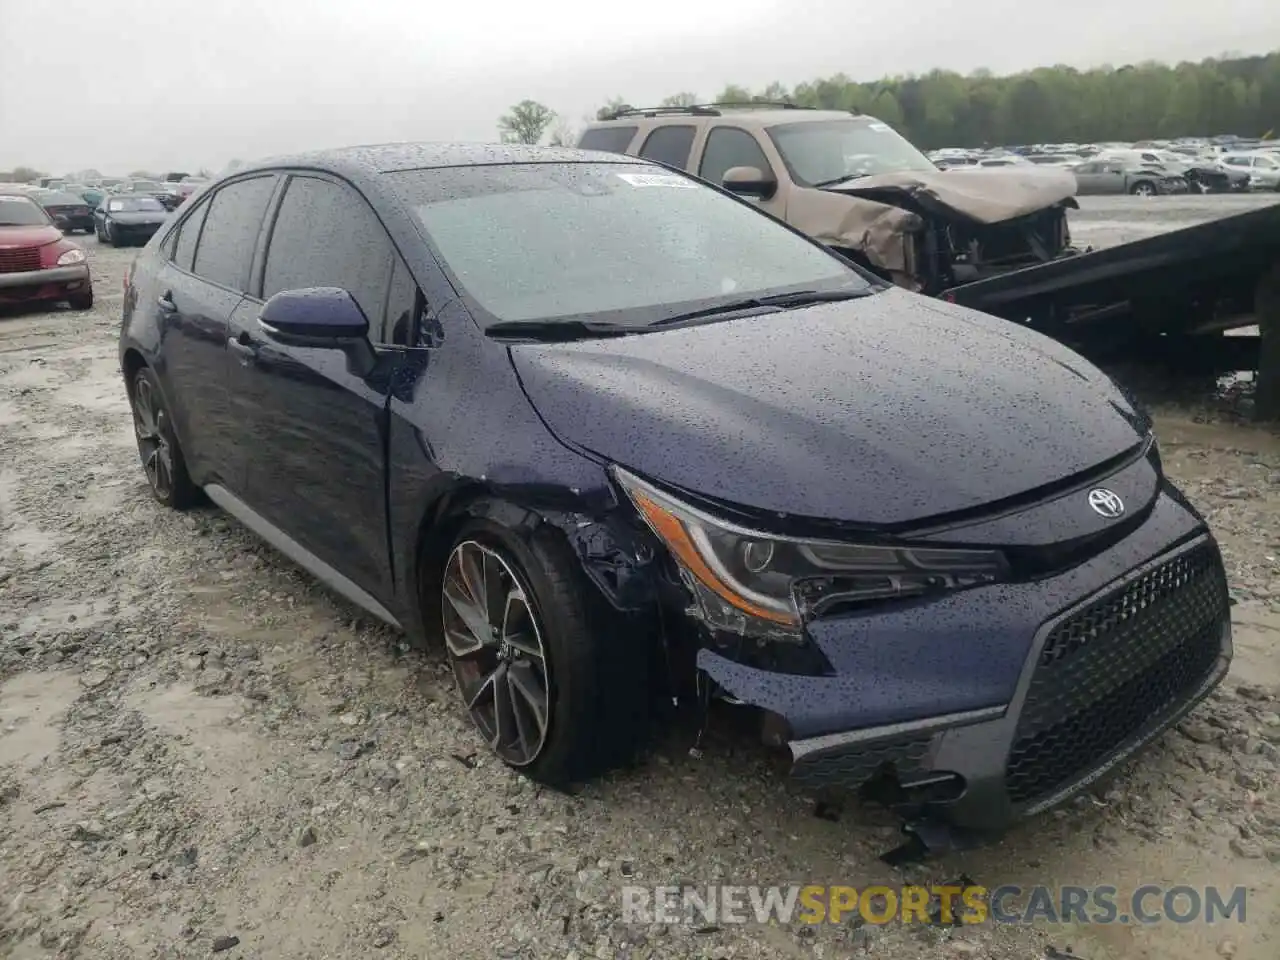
[0,193,93,310]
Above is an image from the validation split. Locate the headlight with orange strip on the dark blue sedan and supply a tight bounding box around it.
[613,467,1007,639]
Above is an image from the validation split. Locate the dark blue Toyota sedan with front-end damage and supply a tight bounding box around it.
[120,145,1231,849]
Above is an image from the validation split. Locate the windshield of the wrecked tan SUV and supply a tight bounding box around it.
[768,118,938,187]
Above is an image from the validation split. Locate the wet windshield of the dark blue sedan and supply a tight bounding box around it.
[385,164,870,326]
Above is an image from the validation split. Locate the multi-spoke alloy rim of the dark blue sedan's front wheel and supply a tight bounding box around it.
[440,540,550,767]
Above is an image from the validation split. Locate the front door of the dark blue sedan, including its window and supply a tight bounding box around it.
[229,168,416,598]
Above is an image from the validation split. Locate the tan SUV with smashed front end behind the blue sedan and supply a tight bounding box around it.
[577,104,1075,294]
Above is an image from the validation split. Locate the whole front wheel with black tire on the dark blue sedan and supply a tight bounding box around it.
[439,518,649,787]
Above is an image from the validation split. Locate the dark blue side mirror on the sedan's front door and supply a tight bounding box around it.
[257,287,378,376]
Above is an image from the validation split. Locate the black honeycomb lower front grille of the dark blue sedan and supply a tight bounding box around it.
[1005,544,1228,803]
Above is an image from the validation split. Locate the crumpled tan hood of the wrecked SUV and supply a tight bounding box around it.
[826,168,1076,223]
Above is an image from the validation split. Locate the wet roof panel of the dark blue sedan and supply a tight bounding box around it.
[236,142,645,175]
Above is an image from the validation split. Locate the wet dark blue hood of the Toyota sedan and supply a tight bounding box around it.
[511,289,1146,526]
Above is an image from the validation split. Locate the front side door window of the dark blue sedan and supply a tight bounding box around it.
[262,177,396,343]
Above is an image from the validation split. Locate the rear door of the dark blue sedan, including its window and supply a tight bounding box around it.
[149,174,276,489]
